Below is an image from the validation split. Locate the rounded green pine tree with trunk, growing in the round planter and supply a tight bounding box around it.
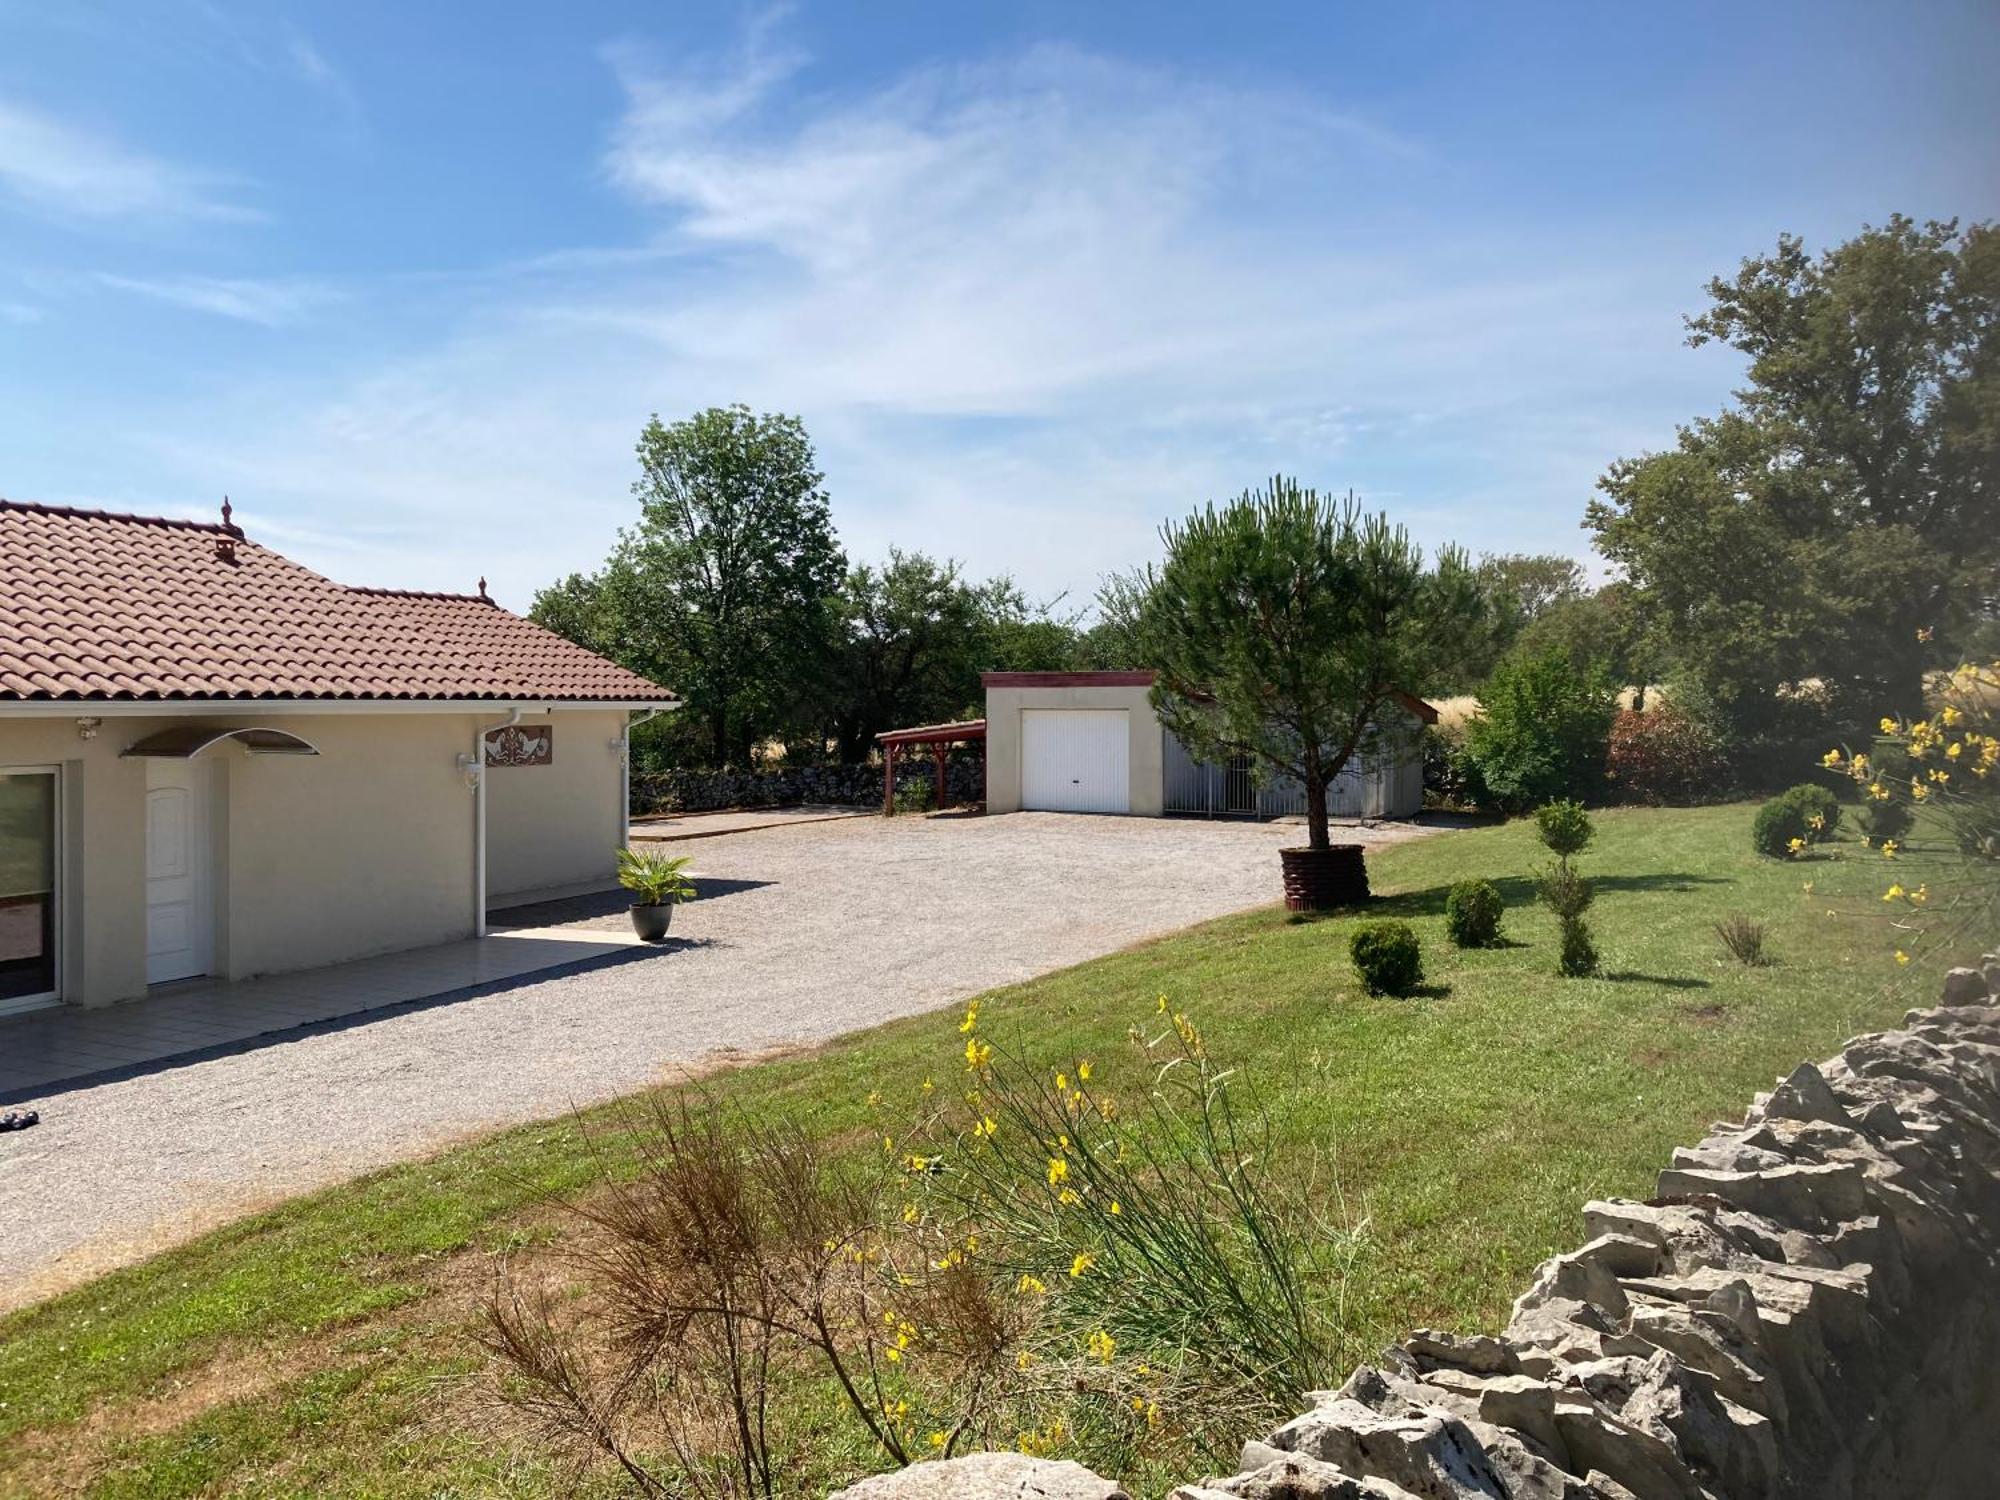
[1112,476,1482,848]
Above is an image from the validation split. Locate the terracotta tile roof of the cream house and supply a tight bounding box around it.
[0,500,674,702]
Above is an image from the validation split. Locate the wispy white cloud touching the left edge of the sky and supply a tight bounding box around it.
[0,100,260,220]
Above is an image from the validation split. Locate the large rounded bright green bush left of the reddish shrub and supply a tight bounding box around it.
[1466,650,1618,812]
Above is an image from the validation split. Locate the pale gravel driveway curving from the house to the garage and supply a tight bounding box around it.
[0,812,1420,1308]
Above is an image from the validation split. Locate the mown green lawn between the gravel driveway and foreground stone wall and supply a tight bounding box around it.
[0,806,1978,1496]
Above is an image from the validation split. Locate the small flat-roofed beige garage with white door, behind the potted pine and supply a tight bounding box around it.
[984,672,1438,818]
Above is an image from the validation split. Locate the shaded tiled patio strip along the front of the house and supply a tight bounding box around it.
[0,926,658,1104]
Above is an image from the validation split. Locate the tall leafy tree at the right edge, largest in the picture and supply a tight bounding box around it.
[1586,216,2000,732]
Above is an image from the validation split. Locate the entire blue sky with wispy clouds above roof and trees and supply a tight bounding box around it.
[0,0,2000,608]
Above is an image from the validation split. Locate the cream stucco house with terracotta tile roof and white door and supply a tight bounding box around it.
[0,500,676,1012]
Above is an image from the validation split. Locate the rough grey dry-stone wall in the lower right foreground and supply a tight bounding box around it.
[840,956,2000,1500]
